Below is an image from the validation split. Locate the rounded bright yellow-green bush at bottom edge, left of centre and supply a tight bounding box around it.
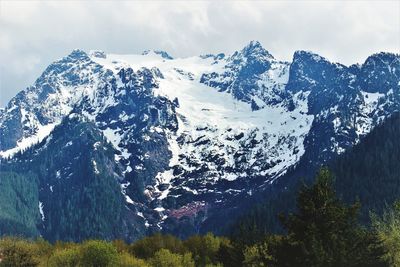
[80,240,118,267]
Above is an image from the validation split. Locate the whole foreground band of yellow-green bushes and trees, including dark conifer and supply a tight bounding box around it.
[0,168,400,267]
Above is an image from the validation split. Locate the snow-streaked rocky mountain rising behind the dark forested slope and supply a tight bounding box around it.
[0,41,400,239]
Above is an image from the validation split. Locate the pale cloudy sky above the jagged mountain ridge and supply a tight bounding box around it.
[0,0,400,107]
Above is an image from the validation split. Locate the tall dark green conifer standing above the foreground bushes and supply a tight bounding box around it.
[272,169,382,267]
